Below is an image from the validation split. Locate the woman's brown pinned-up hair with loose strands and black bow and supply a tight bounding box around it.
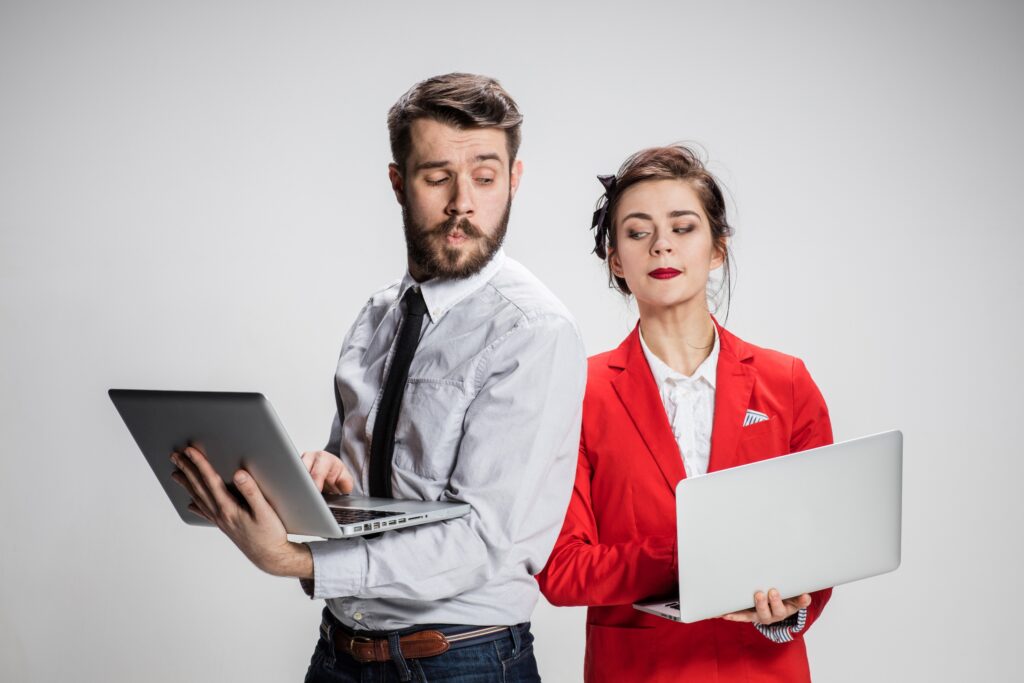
[594,143,733,315]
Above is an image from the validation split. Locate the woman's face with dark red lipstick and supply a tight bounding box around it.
[609,179,724,308]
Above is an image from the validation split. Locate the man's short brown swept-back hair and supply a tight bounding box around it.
[387,74,522,173]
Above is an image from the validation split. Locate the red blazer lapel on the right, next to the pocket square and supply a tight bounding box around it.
[708,321,757,472]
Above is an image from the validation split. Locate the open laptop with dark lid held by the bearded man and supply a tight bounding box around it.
[108,389,470,539]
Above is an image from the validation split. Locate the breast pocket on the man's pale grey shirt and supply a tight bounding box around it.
[392,378,468,482]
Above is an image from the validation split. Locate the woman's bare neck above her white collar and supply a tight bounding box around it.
[638,302,715,377]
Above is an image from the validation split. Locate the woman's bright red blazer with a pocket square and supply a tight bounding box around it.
[538,322,833,683]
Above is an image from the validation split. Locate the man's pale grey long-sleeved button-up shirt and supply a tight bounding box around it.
[309,251,587,631]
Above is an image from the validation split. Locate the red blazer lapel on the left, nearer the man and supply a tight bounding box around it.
[608,325,686,490]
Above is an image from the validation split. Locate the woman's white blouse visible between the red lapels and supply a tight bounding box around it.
[640,330,720,477]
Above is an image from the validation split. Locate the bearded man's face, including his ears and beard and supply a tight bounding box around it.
[389,119,522,282]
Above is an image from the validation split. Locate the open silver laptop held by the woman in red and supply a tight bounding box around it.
[633,431,903,624]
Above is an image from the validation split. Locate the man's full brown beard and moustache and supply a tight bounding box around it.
[401,197,512,280]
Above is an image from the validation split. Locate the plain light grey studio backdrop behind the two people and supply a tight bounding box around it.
[0,0,1024,681]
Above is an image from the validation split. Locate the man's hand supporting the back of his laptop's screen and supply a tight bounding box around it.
[171,446,313,579]
